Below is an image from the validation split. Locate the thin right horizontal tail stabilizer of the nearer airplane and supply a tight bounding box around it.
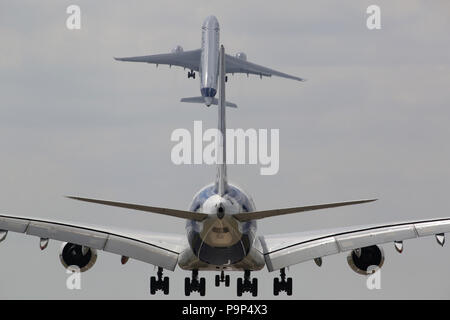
[233,199,377,222]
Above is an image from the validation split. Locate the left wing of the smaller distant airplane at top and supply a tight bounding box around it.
[114,49,201,71]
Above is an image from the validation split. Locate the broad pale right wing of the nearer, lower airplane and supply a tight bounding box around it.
[259,218,450,271]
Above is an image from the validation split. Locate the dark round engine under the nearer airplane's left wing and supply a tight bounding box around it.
[59,242,97,272]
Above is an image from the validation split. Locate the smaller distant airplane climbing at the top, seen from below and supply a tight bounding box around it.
[115,16,305,108]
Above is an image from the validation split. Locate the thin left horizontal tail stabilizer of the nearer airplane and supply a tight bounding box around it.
[67,196,208,221]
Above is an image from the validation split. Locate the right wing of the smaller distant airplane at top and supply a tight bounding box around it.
[225,54,306,81]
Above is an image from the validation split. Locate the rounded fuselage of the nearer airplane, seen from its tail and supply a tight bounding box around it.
[179,184,265,270]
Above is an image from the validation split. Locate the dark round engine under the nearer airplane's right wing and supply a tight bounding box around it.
[347,245,384,275]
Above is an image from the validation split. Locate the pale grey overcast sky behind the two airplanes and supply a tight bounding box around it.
[0,0,450,299]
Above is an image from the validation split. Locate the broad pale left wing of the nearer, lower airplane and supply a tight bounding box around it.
[0,215,188,271]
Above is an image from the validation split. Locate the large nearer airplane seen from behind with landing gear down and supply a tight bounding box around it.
[0,17,450,296]
